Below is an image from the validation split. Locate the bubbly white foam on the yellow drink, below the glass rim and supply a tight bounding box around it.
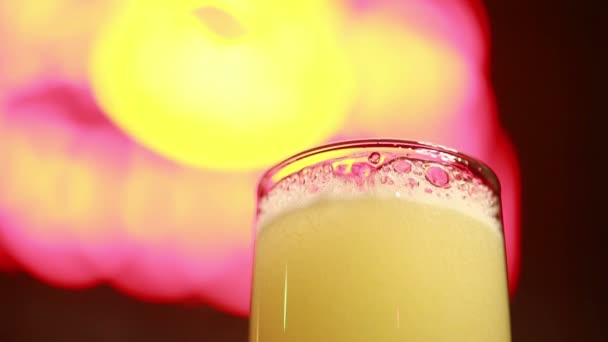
[258,152,501,230]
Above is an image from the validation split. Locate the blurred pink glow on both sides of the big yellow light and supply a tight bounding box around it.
[0,0,521,315]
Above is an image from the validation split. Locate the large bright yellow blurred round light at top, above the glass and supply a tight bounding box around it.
[90,0,352,169]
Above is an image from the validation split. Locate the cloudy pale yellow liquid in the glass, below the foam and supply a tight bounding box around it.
[250,198,510,342]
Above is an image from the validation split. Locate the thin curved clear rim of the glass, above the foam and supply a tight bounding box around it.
[257,139,500,200]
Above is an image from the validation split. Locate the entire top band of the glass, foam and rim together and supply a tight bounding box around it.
[258,140,502,232]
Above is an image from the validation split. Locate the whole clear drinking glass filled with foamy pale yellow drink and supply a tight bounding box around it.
[249,140,511,342]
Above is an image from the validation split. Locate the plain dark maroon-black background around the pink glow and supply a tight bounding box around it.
[0,0,608,342]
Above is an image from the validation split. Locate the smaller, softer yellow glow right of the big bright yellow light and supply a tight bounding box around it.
[347,12,467,131]
